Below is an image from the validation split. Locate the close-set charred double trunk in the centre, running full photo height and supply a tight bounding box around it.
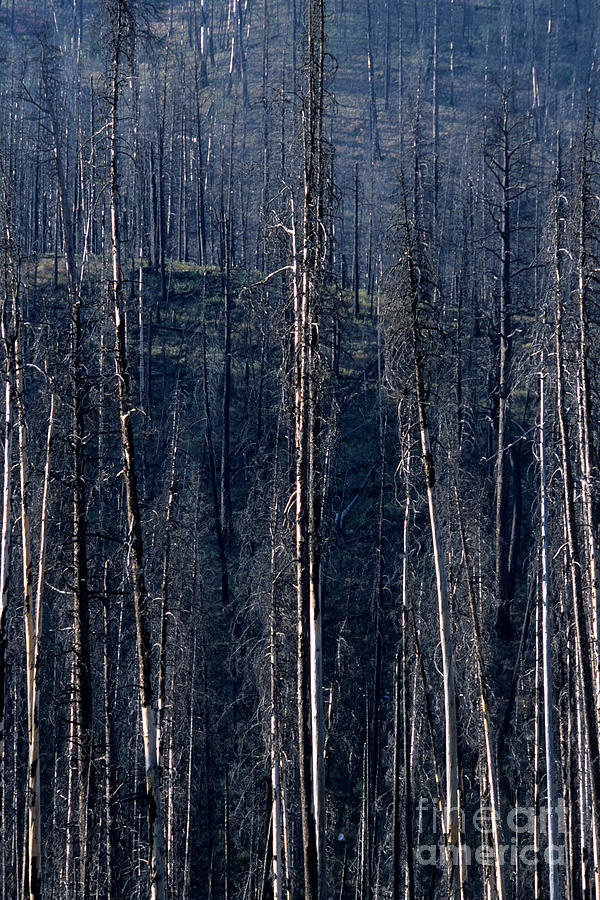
[292,0,327,900]
